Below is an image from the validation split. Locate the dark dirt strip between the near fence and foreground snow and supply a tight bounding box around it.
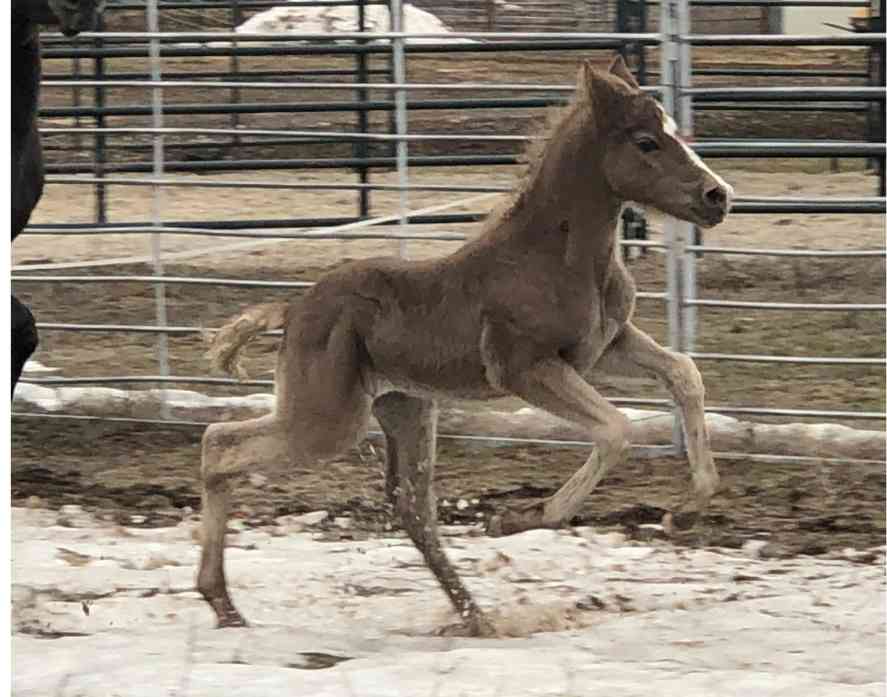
[12,419,885,555]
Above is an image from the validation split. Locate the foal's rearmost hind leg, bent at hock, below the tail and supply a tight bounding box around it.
[197,414,290,627]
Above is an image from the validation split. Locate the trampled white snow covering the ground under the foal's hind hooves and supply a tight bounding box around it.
[12,507,885,697]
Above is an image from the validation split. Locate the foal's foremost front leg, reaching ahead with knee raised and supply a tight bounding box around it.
[593,322,719,510]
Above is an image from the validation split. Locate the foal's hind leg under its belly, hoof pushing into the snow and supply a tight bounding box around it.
[373,392,494,635]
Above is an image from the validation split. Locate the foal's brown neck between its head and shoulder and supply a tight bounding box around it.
[500,105,623,270]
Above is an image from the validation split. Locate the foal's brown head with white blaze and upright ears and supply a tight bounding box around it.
[579,57,733,227]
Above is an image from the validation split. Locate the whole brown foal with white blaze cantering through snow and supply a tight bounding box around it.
[197,58,733,634]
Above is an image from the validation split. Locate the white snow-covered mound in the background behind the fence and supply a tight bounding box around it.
[237,5,468,43]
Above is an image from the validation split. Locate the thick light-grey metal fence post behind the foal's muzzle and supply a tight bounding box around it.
[659,0,685,453]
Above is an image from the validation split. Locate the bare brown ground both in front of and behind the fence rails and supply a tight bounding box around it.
[12,44,885,555]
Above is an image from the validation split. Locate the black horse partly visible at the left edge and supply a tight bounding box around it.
[11,0,104,393]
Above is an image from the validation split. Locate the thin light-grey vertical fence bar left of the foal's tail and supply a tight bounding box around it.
[147,0,169,410]
